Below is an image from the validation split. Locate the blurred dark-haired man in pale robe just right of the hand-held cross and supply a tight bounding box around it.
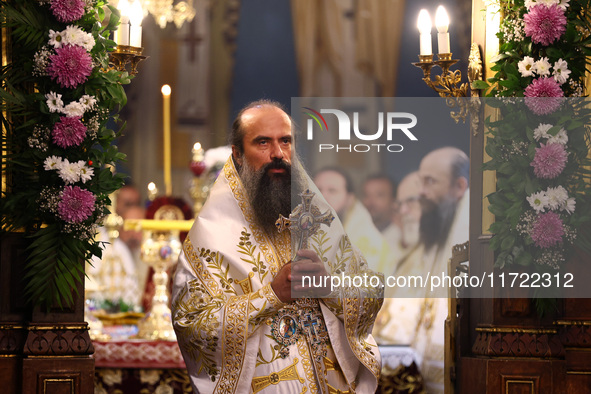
[314,167,391,272]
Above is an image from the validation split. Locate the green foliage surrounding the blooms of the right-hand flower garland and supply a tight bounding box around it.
[477,0,591,315]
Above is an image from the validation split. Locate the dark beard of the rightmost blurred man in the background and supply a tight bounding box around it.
[419,198,457,250]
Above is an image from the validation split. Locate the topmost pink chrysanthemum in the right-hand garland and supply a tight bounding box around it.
[523,4,566,46]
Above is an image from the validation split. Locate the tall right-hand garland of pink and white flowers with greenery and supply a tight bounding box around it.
[476,0,591,306]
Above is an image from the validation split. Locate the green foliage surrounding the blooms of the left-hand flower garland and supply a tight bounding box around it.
[0,0,130,307]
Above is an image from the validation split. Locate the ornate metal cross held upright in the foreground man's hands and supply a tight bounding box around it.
[275,189,334,261]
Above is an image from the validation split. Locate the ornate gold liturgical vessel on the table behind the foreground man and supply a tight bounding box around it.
[137,205,183,341]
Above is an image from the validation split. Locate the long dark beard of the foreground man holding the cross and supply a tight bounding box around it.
[239,160,301,234]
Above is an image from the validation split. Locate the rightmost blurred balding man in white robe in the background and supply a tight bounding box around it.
[386,147,470,393]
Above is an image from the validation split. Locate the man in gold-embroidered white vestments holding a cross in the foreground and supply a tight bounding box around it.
[173,102,382,393]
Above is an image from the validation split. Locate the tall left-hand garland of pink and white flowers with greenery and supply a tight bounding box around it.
[0,0,129,306]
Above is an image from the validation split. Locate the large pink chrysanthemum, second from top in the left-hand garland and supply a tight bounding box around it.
[47,45,92,88]
